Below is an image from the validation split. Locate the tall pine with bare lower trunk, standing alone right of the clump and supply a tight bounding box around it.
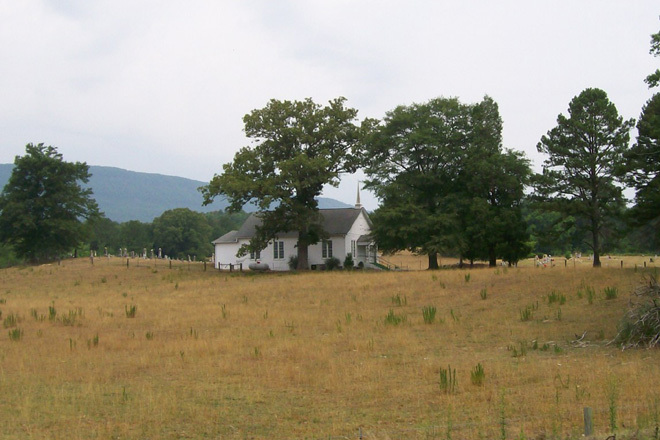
[534,89,634,267]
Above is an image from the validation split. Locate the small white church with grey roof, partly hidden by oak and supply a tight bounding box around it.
[213,202,378,271]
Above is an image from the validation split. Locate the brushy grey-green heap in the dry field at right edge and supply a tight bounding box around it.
[615,276,660,348]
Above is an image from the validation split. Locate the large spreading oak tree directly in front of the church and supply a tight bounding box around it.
[201,98,369,269]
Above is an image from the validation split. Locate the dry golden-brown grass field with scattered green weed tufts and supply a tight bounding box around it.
[0,255,660,439]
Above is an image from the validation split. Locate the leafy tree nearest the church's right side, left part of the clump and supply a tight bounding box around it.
[365,98,470,269]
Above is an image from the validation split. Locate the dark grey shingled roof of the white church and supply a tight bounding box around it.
[226,208,371,243]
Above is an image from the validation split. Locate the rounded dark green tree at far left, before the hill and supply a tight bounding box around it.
[0,144,98,262]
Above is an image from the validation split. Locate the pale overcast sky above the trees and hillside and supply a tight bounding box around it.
[0,0,660,209]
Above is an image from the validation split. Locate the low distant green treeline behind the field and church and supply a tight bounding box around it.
[0,203,660,267]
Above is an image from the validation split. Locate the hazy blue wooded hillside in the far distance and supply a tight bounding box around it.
[0,164,350,223]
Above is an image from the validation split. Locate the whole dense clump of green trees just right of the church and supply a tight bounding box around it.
[366,97,529,269]
